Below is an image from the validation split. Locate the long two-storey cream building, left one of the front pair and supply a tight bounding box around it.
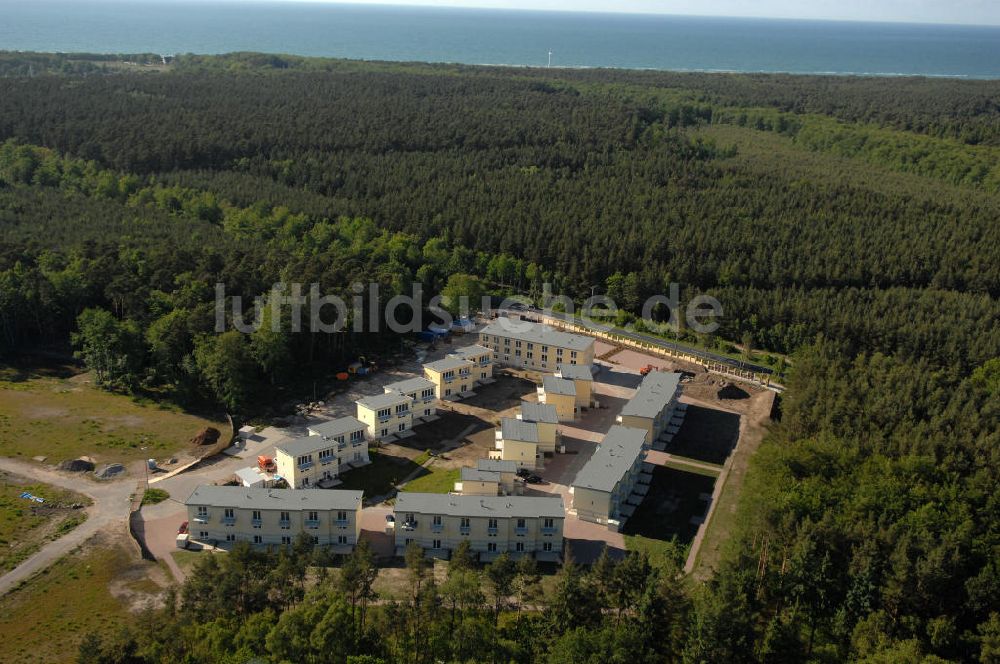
[185,485,363,553]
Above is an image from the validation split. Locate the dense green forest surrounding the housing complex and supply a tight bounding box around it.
[0,54,1000,663]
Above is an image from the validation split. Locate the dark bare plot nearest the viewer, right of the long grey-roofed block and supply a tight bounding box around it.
[624,466,715,557]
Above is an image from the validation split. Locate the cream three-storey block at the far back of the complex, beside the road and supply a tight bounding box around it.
[479,318,594,372]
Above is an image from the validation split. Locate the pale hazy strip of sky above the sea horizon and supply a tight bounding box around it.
[264,0,1000,25]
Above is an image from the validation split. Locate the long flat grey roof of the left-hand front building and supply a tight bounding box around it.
[184,484,364,511]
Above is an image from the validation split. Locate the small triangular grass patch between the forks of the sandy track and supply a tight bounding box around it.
[0,473,90,572]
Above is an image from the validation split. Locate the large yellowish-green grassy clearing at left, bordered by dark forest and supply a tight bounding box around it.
[0,369,225,463]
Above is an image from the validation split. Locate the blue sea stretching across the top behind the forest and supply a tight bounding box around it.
[0,0,1000,79]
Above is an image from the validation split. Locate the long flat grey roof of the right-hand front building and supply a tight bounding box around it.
[393,491,566,519]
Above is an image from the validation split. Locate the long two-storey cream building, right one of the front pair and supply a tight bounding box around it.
[393,491,565,562]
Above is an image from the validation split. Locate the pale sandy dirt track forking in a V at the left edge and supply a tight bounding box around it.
[0,457,141,595]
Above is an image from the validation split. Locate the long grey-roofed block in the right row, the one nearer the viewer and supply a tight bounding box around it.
[571,425,652,530]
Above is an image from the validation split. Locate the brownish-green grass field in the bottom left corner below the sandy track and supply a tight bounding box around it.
[0,540,158,664]
